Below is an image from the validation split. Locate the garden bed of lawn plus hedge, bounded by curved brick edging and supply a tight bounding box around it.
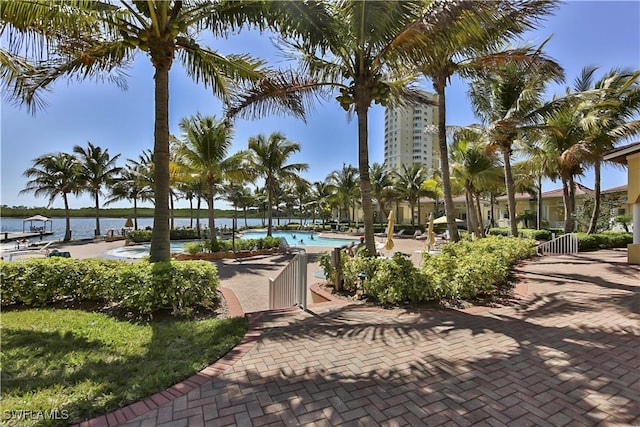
[0,258,248,425]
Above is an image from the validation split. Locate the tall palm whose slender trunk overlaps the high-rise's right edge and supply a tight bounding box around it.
[418,0,557,241]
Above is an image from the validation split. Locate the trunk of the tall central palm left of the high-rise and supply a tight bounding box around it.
[356,102,376,255]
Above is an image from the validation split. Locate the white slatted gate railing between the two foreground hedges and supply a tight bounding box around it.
[269,252,307,310]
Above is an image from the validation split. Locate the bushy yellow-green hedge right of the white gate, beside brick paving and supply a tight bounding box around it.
[332,236,536,304]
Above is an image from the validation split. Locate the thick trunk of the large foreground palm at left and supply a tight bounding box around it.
[149,60,171,262]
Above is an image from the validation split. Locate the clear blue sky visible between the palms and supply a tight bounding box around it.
[0,1,640,211]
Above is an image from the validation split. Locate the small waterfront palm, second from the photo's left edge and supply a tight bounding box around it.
[73,142,121,236]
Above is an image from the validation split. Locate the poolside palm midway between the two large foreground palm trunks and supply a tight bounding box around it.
[249,132,309,236]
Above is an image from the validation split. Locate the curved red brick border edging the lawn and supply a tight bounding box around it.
[77,287,263,427]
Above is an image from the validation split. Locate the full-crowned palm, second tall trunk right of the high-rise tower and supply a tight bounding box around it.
[469,51,563,236]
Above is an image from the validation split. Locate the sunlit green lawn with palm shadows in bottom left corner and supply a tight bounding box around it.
[0,309,248,425]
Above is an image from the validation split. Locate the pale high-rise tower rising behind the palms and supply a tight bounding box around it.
[384,93,440,171]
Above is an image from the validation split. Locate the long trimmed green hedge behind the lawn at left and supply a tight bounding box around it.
[0,258,220,315]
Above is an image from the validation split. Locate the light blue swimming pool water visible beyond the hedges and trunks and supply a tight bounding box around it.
[106,231,358,259]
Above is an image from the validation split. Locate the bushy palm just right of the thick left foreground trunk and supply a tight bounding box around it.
[176,113,242,241]
